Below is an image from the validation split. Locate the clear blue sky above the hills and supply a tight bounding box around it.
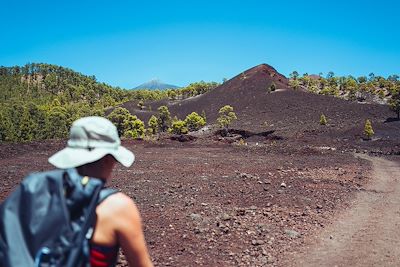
[0,0,400,88]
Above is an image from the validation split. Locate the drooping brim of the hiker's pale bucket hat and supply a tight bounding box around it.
[49,146,135,169]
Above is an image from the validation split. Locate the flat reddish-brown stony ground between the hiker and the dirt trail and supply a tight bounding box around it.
[0,141,370,266]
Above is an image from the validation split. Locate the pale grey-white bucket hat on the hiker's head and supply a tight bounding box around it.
[49,116,135,169]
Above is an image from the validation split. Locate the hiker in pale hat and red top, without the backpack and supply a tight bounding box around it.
[49,117,153,267]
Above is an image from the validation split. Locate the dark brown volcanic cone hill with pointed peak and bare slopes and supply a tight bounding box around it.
[123,64,400,152]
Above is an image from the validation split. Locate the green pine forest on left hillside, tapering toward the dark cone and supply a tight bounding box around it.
[0,63,218,142]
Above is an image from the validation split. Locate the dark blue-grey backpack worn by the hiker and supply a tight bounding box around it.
[0,169,116,267]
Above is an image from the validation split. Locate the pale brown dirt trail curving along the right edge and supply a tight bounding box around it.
[288,155,400,266]
